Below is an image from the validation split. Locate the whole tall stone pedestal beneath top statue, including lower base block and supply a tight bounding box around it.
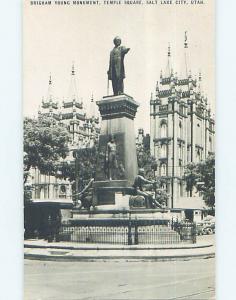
[94,94,139,209]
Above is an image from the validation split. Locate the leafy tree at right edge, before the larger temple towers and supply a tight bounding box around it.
[185,155,215,209]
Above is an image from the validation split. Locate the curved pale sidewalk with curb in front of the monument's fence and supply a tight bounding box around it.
[24,236,215,261]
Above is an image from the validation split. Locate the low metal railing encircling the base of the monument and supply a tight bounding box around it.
[59,219,196,245]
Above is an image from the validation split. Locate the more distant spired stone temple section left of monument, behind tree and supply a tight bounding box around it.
[31,65,100,199]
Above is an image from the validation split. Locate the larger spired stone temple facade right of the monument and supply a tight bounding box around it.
[150,36,215,208]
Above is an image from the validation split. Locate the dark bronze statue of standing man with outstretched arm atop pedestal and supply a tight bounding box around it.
[107,36,130,96]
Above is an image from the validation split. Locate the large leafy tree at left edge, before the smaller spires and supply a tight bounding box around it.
[24,117,69,183]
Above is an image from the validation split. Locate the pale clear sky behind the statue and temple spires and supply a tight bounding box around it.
[23,1,215,132]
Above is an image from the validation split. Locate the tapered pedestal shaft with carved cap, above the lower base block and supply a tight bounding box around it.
[96,94,138,185]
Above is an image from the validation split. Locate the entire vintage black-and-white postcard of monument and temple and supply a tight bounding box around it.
[22,0,216,300]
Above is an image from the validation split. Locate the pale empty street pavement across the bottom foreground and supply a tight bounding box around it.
[24,258,215,300]
